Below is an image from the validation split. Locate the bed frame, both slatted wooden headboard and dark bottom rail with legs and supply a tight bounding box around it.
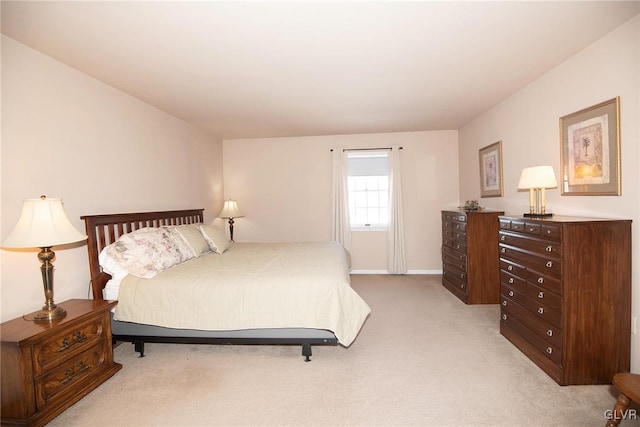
[81,209,338,362]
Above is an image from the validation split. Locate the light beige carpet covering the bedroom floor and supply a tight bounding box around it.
[50,275,624,427]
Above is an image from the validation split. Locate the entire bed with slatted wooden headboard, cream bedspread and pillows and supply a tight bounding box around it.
[82,209,370,361]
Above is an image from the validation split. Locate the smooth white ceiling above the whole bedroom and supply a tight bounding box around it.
[1,0,640,139]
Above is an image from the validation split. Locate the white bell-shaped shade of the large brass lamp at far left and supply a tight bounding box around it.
[2,196,87,248]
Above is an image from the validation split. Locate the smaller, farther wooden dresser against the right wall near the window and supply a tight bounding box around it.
[442,210,504,304]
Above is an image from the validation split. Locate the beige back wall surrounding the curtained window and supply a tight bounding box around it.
[223,131,458,272]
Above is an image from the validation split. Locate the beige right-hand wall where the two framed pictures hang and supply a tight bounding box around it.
[460,16,640,372]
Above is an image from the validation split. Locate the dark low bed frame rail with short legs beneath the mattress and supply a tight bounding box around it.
[113,335,338,362]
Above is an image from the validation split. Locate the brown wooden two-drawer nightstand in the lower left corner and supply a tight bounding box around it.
[0,299,122,426]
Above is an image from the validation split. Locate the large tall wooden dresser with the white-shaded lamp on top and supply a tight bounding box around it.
[500,216,631,385]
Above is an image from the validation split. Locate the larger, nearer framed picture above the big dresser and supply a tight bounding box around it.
[560,97,621,196]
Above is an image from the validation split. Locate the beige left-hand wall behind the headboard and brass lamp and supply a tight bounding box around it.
[0,36,222,321]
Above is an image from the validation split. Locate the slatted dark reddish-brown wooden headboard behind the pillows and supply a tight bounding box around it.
[80,209,204,299]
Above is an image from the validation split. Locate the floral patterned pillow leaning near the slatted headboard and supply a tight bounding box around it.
[106,227,195,279]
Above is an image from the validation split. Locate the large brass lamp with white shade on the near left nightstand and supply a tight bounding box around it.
[2,196,87,320]
